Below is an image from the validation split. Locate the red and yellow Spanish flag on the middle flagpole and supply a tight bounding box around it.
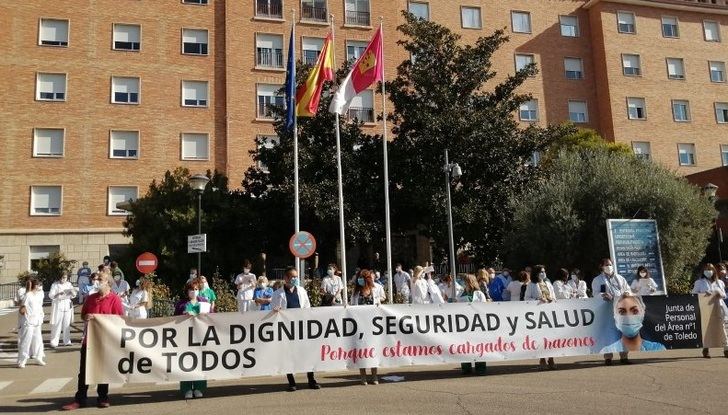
[296,33,334,117]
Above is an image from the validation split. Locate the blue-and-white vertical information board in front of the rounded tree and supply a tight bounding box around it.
[607,219,667,295]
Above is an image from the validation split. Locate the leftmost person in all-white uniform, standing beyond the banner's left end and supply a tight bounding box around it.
[18,278,45,369]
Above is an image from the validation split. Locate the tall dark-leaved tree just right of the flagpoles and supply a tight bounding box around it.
[387,12,574,262]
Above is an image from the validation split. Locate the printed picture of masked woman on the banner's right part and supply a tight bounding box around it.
[600,292,665,353]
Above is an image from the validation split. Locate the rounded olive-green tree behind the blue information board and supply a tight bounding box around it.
[506,149,715,293]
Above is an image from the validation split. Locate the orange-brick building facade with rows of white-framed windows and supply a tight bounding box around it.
[0,0,728,282]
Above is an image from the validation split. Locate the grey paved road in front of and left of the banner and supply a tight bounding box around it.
[0,304,728,415]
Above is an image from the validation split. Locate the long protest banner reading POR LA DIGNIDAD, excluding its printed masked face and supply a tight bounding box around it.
[86,296,717,383]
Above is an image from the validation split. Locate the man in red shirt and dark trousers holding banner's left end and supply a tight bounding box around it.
[62,273,124,411]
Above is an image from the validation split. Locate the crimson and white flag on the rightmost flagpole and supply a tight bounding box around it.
[329,27,384,115]
